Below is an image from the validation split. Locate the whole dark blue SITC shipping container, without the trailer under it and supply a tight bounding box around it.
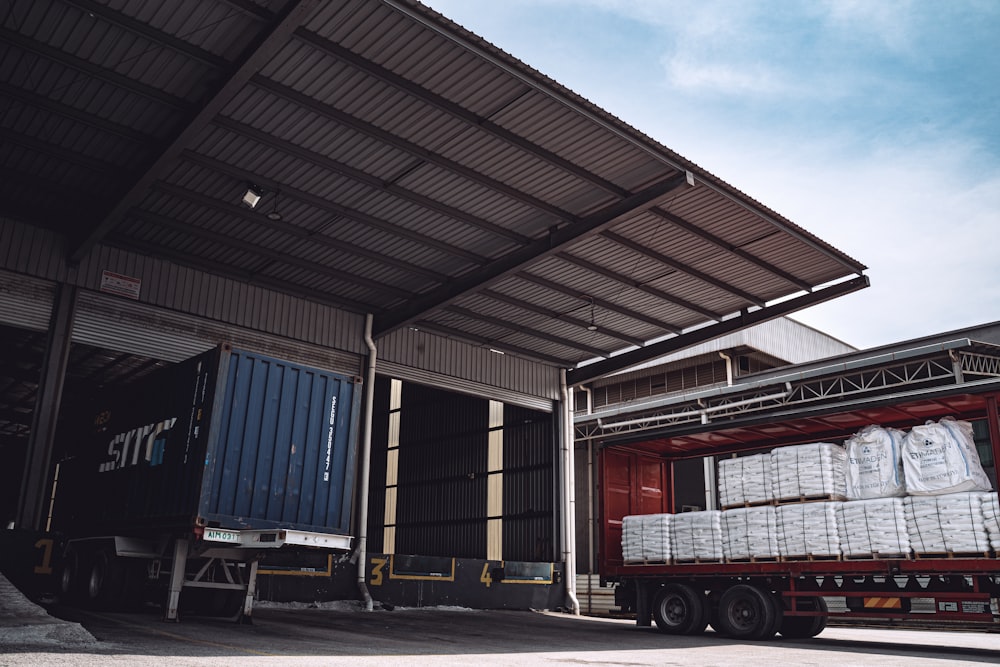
[53,345,361,536]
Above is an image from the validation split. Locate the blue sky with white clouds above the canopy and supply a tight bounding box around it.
[424,0,1000,348]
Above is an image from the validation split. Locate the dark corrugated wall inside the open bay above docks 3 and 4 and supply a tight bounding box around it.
[368,375,556,562]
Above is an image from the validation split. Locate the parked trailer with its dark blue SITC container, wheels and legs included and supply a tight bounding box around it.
[51,344,361,620]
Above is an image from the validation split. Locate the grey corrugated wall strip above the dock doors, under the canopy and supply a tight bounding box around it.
[0,218,559,410]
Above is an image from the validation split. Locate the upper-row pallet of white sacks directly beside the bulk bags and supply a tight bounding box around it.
[771,442,847,500]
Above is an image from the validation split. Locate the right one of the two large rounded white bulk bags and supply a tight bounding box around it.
[903,417,993,496]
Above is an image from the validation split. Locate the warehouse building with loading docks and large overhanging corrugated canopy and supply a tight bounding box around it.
[0,0,868,607]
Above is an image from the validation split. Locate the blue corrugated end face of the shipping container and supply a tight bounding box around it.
[199,350,361,534]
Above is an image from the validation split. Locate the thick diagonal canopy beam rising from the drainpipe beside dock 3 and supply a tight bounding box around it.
[374,172,693,336]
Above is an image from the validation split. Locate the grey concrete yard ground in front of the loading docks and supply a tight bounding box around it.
[0,603,1000,667]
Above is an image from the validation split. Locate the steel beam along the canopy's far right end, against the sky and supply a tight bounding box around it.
[566,276,870,386]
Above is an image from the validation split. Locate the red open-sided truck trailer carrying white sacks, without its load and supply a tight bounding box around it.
[598,379,1000,639]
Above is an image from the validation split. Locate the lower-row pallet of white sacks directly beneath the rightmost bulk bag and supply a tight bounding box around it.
[904,492,990,554]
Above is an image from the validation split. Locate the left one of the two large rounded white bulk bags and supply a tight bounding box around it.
[844,425,906,500]
